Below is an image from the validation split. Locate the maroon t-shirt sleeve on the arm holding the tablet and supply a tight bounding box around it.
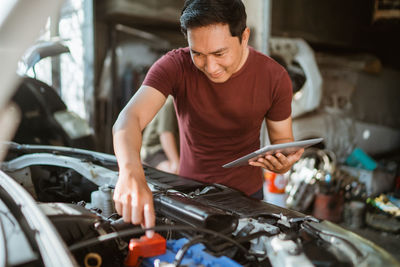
[265,70,293,121]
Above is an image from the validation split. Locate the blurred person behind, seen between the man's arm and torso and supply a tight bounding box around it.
[140,96,179,174]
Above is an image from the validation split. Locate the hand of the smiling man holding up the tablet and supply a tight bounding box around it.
[249,148,304,173]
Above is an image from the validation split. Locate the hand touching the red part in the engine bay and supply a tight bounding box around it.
[114,170,155,238]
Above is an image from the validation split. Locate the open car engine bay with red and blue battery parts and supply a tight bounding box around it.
[0,144,392,266]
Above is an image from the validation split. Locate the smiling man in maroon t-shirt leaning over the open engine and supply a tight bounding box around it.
[113,0,303,236]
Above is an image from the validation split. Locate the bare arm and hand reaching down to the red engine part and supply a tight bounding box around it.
[113,86,166,235]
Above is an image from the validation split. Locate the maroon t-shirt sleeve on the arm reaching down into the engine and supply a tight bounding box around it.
[143,52,179,97]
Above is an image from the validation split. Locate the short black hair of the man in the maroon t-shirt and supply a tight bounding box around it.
[181,0,247,42]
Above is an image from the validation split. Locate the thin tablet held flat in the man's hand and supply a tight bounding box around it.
[222,138,323,168]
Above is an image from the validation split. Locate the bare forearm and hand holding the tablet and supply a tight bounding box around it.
[249,117,304,173]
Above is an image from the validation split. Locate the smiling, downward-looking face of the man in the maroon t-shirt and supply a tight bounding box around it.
[187,24,249,83]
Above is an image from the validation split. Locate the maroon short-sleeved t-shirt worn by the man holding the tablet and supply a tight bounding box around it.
[143,47,292,195]
